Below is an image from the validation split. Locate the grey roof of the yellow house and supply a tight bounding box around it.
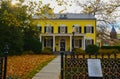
[32,13,96,20]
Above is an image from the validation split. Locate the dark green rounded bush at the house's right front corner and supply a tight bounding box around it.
[85,45,99,54]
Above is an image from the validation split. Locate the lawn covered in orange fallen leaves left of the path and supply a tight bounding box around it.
[7,55,55,79]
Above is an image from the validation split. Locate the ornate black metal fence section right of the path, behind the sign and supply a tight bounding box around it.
[61,54,120,79]
